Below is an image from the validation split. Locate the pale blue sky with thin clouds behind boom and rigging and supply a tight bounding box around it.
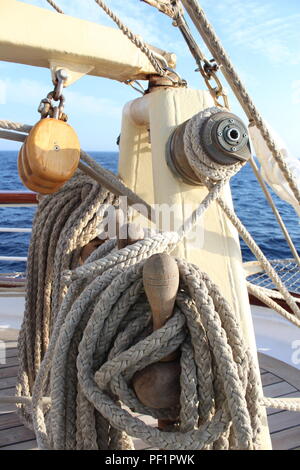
[0,0,300,157]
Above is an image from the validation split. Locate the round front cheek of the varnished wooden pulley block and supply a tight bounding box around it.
[25,118,80,185]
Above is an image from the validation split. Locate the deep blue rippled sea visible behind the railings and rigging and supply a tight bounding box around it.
[0,151,300,273]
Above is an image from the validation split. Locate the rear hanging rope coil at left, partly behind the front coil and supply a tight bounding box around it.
[17,172,115,428]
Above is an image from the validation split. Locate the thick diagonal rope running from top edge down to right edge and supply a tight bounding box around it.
[182,0,300,204]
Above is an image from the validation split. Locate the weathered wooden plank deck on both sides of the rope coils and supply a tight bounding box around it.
[0,331,300,450]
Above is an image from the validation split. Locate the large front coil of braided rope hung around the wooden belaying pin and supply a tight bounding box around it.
[32,239,260,449]
